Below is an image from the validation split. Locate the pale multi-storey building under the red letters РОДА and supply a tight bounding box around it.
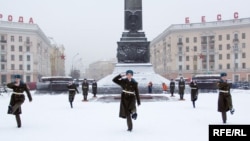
[0,21,64,84]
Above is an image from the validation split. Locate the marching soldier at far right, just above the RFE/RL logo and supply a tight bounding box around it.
[217,73,235,123]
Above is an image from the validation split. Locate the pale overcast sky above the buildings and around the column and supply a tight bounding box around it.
[0,0,250,73]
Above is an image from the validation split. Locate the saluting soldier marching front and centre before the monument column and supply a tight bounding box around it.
[113,70,141,132]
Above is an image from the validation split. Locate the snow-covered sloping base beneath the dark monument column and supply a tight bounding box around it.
[97,63,170,94]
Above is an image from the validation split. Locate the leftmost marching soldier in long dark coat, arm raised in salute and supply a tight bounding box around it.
[7,75,32,128]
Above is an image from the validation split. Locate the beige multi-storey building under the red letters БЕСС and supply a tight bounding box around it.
[150,18,250,82]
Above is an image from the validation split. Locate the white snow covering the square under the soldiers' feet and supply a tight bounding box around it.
[0,89,250,141]
